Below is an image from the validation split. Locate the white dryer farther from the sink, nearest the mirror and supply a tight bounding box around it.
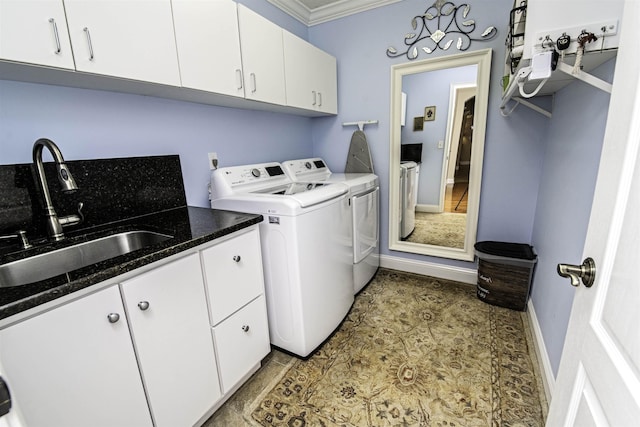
[282,158,380,294]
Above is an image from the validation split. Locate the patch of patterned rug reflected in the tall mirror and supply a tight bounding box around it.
[407,212,467,249]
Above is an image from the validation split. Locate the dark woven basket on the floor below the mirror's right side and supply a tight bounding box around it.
[476,242,537,311]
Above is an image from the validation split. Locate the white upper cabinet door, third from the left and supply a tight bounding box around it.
[171,0,244,97]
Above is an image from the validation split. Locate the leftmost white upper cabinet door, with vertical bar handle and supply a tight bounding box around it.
[0,0,74,70]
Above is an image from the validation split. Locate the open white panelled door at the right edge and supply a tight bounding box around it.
[547,0,640,426]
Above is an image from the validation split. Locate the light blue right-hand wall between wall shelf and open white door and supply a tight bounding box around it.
[528,61,615,373]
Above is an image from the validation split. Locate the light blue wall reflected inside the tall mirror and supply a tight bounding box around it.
[401,65,478,205]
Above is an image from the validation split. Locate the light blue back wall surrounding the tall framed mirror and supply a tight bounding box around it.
[309,0,548,267]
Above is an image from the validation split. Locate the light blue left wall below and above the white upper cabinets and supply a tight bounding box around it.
[0,0,313,206]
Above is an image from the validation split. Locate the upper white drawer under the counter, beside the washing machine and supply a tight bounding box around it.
[202,229,264,325]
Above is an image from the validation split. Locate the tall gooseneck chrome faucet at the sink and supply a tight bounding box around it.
[33,138,83,241]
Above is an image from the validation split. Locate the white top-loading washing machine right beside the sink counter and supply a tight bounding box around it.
[211,163,354,357]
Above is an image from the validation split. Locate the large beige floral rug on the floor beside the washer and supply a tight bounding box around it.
[244,269,544,427]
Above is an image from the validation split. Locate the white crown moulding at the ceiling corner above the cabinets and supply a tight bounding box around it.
[269,0,400,26]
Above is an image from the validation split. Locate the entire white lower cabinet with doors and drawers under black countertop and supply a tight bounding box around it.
[0,226,270,427]
